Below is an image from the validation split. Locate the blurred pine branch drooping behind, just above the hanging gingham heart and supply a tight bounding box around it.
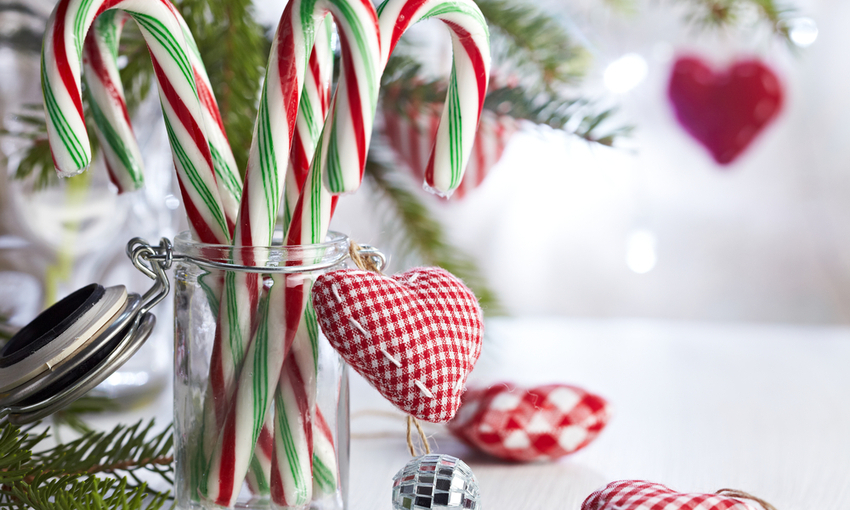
[365,152,503,316]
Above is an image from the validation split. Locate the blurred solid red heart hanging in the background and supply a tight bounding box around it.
[667,57,783,165]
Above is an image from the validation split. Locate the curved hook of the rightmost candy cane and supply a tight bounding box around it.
[378,0,490,196]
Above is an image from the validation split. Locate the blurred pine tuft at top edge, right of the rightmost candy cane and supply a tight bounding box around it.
[477,0,589,88]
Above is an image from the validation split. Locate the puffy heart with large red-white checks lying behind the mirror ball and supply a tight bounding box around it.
[448,383,610,462]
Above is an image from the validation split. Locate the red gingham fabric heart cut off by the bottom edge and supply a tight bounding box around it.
[581,480,761,510]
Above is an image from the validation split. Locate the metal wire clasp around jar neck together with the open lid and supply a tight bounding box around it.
[0,233,387,425]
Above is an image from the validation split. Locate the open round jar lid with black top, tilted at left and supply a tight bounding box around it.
[0,284,155,424]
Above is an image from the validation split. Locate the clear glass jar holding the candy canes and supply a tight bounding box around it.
[174,232,349,510]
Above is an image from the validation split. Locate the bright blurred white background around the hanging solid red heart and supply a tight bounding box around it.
[322,0,850,324]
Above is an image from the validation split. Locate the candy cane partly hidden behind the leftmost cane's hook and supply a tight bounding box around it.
[83,3,242,227]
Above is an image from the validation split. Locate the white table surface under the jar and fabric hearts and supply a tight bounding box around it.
[93,317,850,510]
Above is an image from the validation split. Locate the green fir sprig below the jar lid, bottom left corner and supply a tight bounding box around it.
[0,422,173,510]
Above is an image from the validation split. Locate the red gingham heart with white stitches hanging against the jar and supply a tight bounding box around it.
[313,268,484,423]
